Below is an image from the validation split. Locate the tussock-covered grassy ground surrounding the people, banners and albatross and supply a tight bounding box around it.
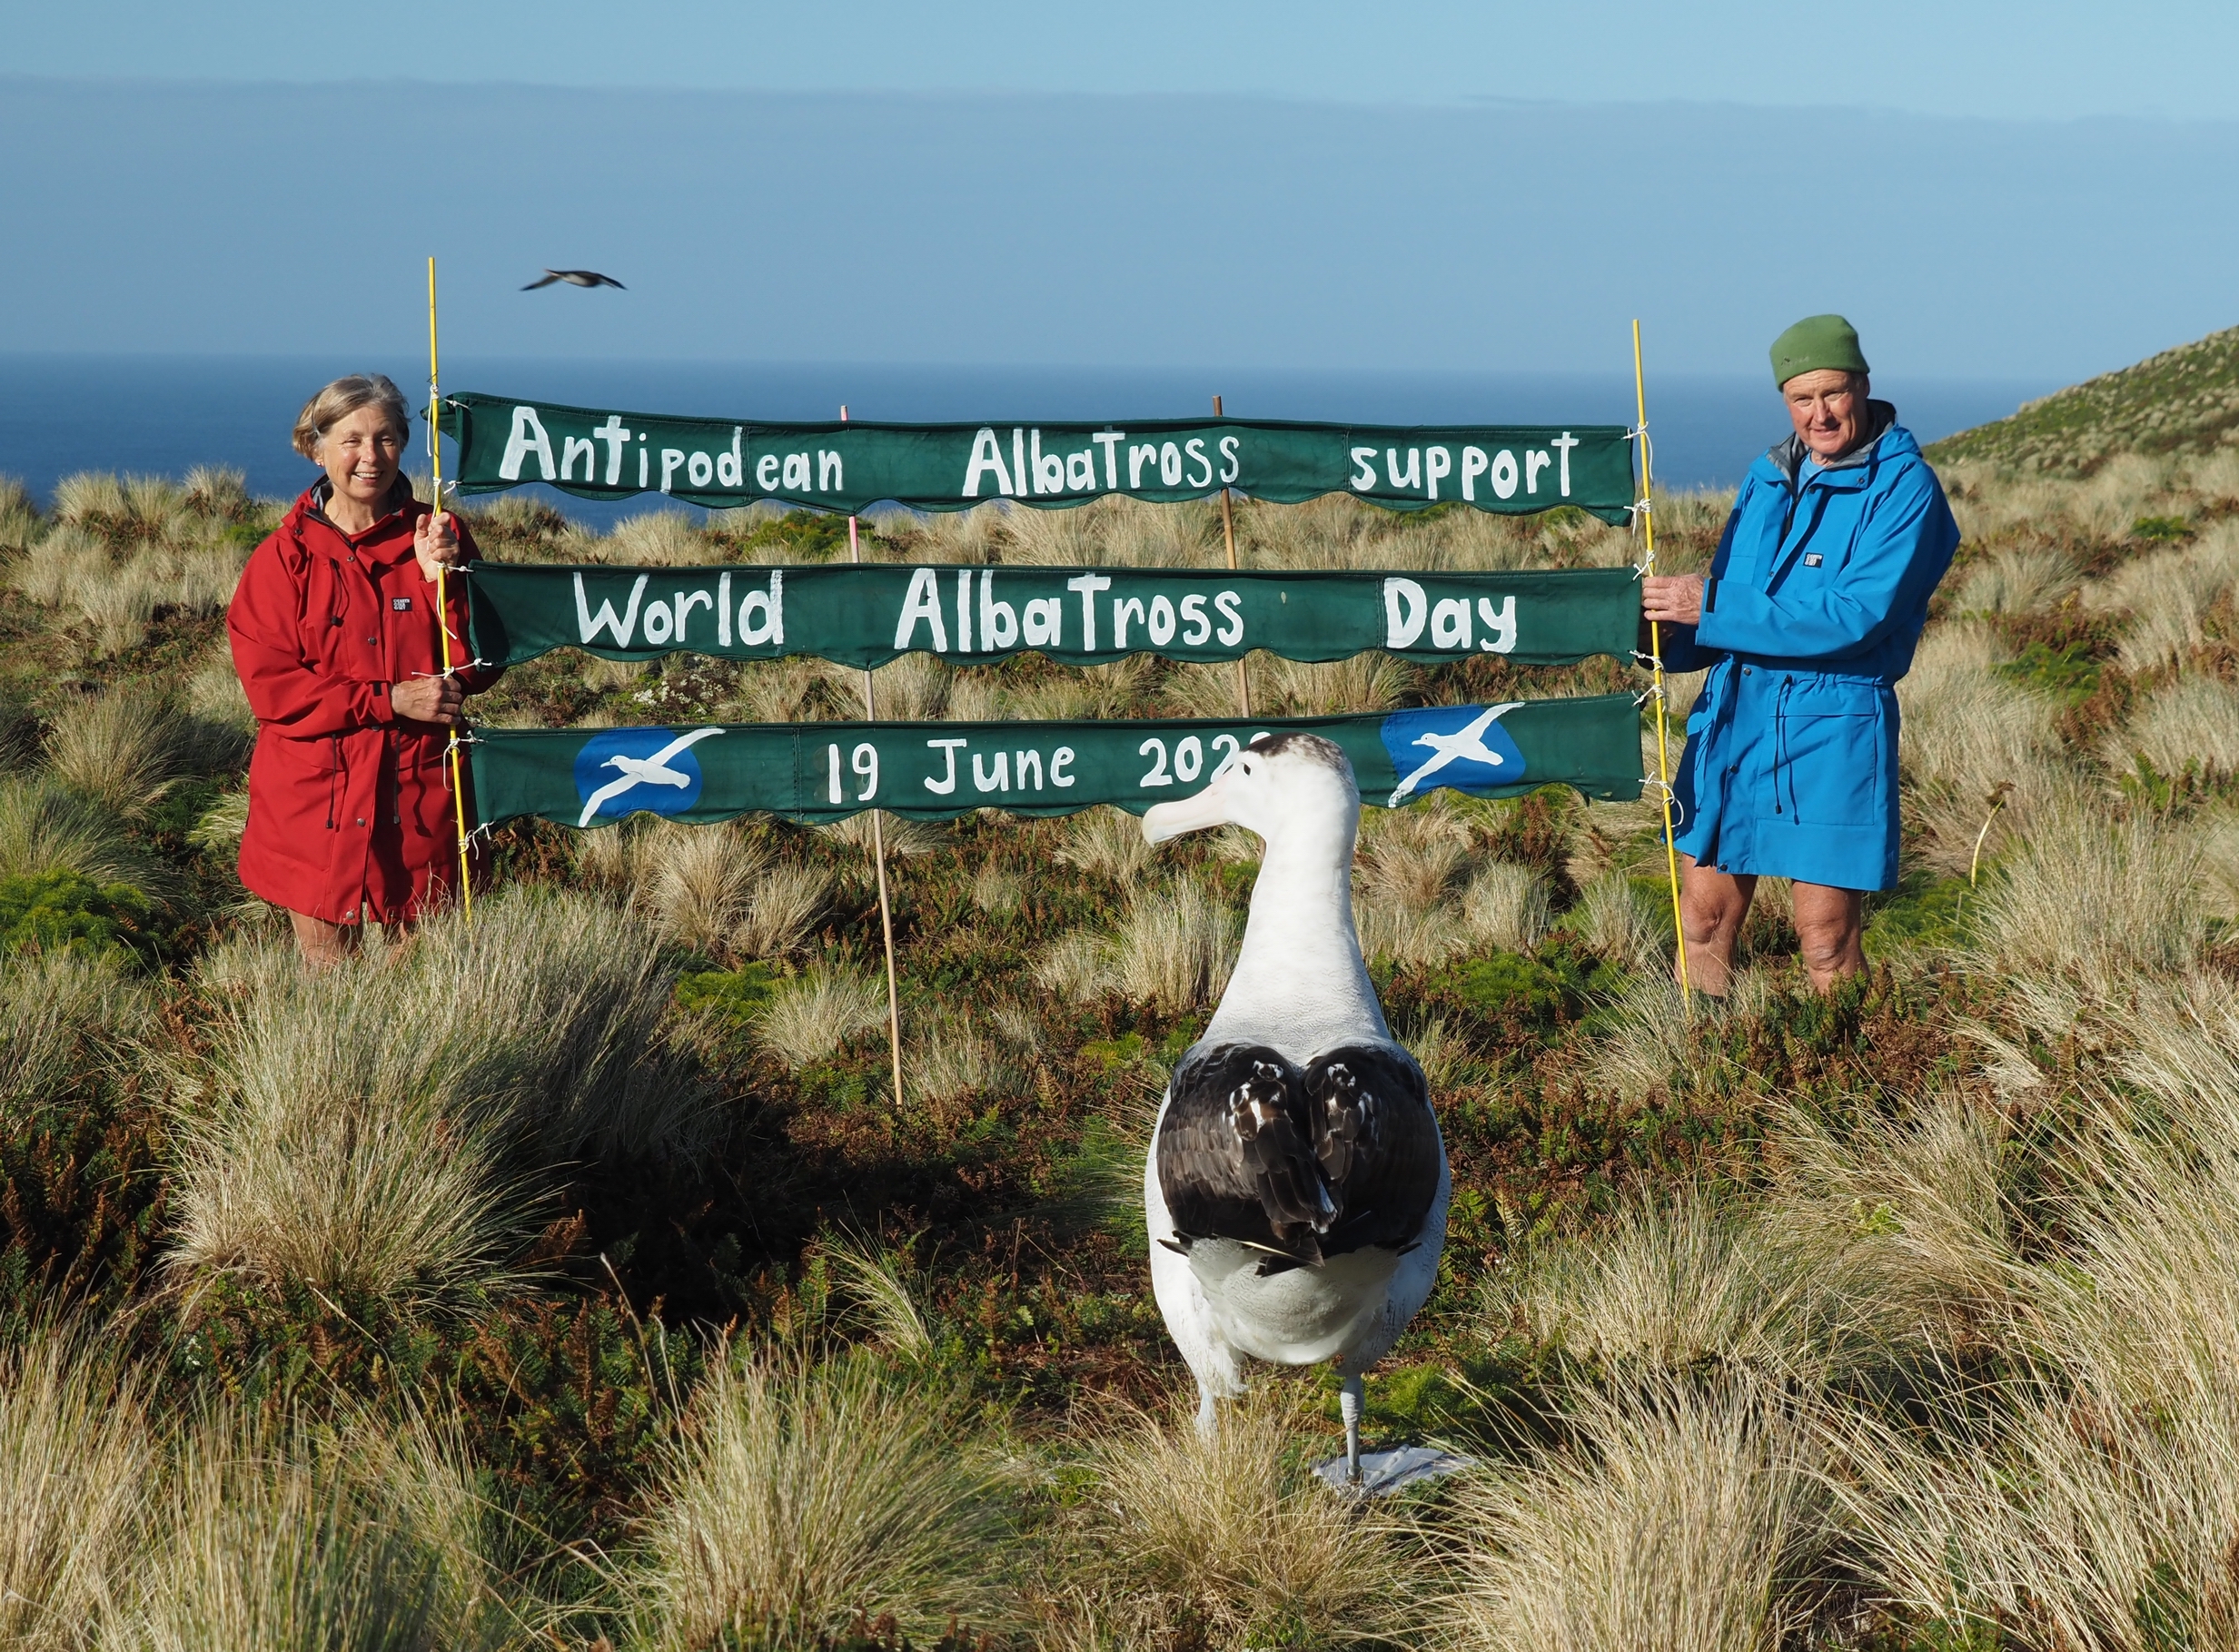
[0,443,2239,1652]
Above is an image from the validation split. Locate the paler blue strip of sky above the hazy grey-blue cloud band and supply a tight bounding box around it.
[13,0,2239,119]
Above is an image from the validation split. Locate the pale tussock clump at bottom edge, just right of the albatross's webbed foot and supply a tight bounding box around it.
[1441,1381,1825,1652]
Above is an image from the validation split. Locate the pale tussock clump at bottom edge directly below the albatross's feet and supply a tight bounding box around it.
[1041,1399,1431,1652]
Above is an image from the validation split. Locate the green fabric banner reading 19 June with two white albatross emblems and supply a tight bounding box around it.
[466,694,1641,828]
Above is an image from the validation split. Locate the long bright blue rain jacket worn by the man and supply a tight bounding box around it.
[1663,401,1959,889]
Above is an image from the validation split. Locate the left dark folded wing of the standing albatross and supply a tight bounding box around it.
[1153,1044,1339,1262]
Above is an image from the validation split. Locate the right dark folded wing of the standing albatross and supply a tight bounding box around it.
[1305,1045,1441,1256]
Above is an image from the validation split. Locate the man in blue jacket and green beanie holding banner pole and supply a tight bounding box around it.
[1641,316,1959,994]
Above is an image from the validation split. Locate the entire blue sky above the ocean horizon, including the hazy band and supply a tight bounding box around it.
[0,0,2239,381]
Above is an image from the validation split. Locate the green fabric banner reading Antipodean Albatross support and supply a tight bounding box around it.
[443,391,1634,521]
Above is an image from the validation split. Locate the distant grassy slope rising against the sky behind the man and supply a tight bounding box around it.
[1927,327,2239,477]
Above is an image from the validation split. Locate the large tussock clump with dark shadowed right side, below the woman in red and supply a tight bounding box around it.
[170,891,709,1301]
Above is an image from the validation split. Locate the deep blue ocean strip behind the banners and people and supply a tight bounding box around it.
[0,353,2057,524]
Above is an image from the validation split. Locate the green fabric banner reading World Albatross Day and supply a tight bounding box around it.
[468,562,1641,665]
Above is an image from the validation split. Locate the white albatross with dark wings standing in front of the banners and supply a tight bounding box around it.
[1142,734,1453,1482]
